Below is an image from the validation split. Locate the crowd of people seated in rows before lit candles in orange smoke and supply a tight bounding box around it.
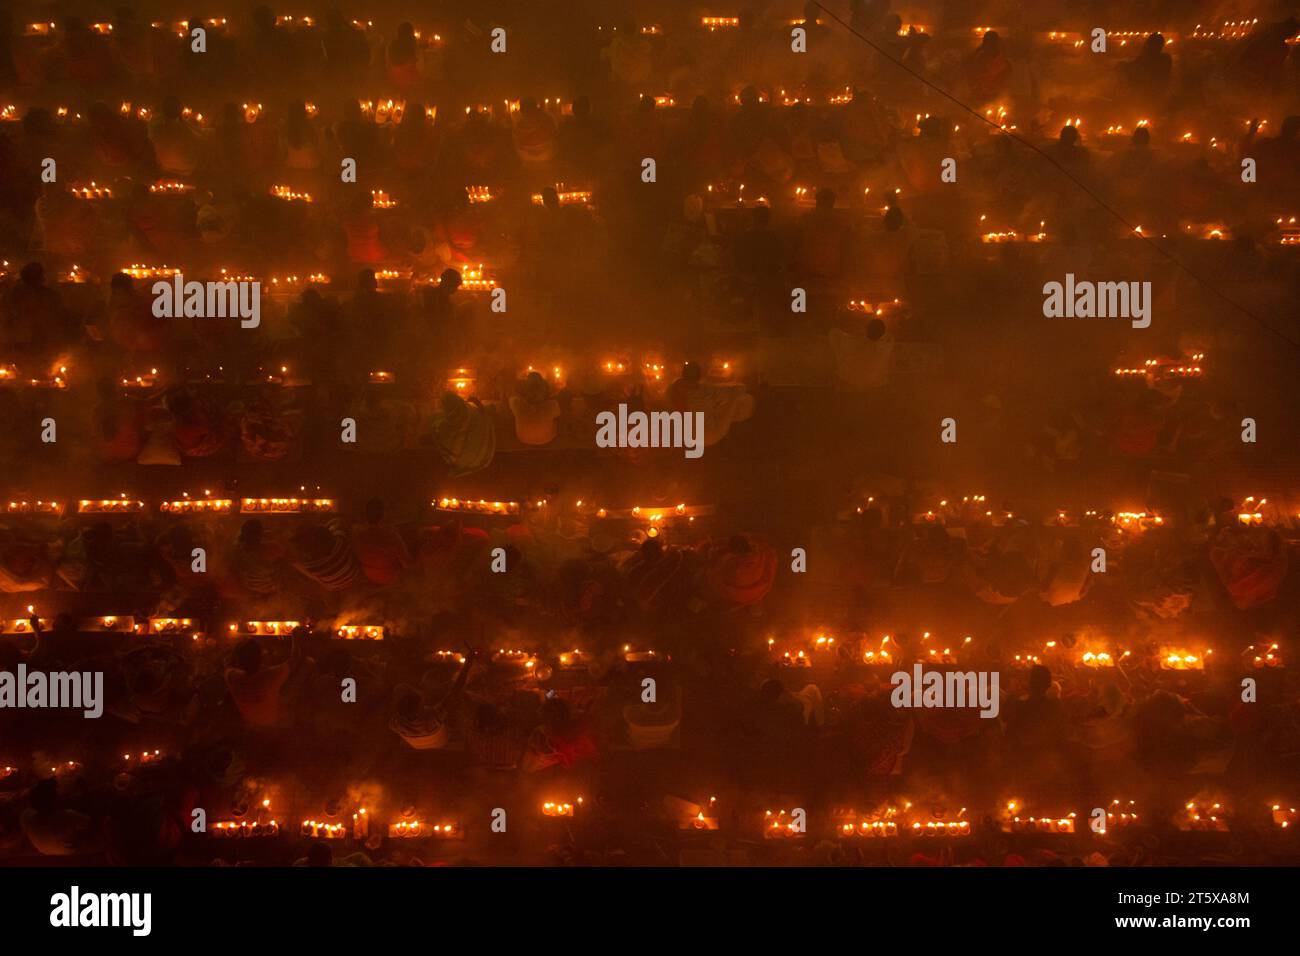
[0,0,1300,865]
